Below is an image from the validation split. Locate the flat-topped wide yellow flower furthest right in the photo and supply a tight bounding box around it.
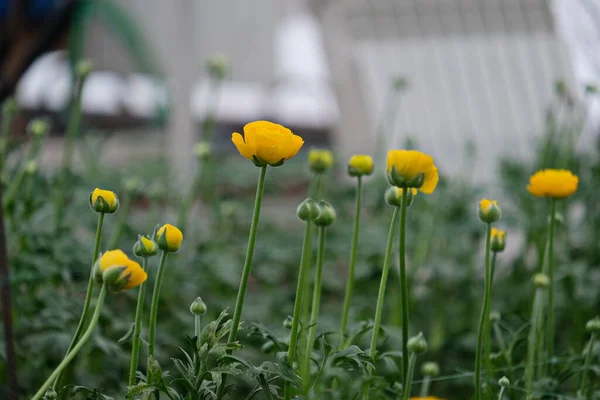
[527,169,579,199]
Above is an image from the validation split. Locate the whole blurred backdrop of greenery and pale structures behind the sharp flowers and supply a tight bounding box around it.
[0,0,600,400]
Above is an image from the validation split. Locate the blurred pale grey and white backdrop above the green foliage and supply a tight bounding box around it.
[3,0,600,179]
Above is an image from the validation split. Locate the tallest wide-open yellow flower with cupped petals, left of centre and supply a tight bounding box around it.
[231,121,304,167]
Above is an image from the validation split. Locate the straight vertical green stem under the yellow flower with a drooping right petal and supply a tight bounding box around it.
[400,188,410,388]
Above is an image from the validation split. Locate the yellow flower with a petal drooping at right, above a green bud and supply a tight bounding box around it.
[386,150,439,194]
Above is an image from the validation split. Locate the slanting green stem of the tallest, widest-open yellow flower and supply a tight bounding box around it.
[217,165,267,399]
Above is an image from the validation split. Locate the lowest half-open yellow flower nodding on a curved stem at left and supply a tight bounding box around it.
[94,250,148,291]
